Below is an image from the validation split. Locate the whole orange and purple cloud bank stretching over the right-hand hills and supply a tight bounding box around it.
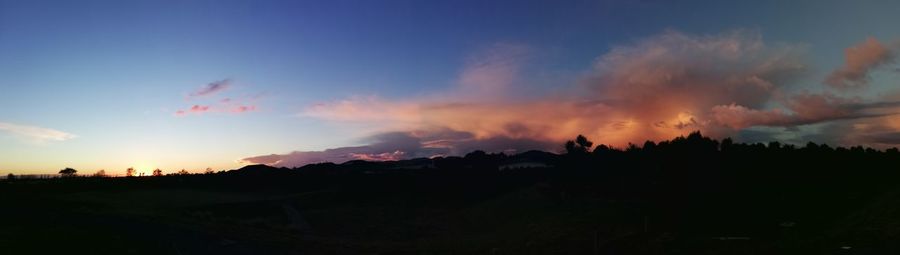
[244,31,900,166]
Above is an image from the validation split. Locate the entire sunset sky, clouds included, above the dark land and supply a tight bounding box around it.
[0,0,900,175]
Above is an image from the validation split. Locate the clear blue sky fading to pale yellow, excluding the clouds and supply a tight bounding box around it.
[0,0,900,173]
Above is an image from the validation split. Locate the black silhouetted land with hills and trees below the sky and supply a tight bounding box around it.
[0,133,900,254]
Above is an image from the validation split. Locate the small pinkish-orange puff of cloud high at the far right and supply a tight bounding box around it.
[825,37,895,89]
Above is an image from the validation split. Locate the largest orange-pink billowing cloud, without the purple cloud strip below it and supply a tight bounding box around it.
[301,31,805,145]
